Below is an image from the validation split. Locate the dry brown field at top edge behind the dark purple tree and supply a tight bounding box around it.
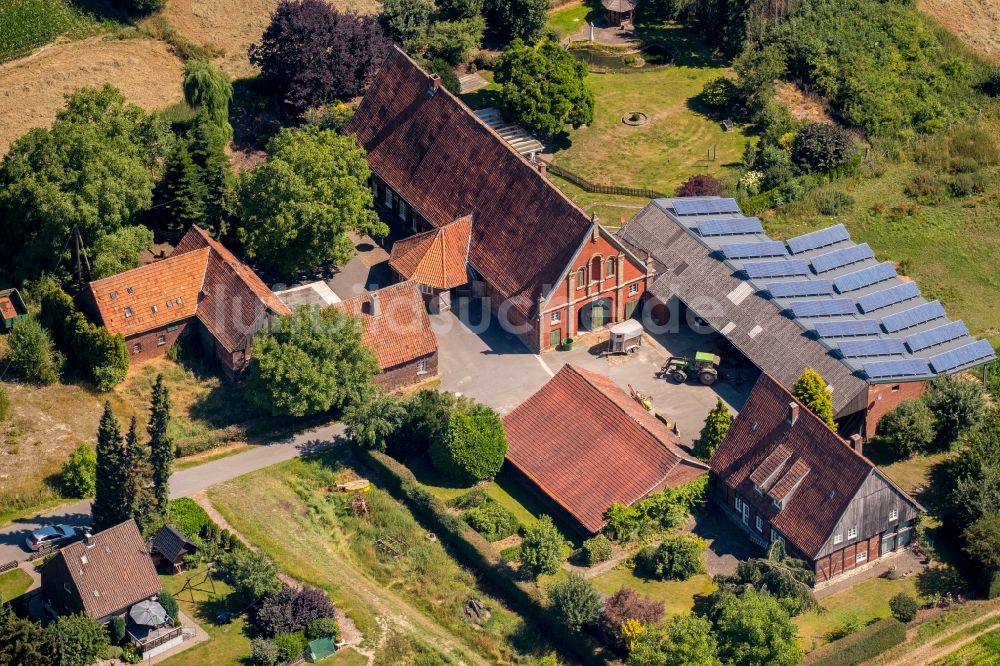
[163,0,379,78]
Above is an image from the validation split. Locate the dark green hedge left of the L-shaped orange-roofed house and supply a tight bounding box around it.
[38,281,129,392]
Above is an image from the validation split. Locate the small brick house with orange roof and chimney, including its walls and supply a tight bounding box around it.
[330,282,438,391]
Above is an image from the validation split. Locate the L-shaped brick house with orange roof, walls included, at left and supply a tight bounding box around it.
[82,226,290,375]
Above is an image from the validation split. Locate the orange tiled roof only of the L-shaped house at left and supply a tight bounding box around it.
[89,226,290,352]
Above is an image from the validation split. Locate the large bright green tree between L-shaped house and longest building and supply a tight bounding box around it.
[239,128,389,274]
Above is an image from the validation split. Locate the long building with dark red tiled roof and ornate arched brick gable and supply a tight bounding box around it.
[346,48,649,351]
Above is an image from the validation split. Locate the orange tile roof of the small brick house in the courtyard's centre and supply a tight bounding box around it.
[330,282,437,370]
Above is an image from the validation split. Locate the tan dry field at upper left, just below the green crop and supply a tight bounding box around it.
[0,37,184,155]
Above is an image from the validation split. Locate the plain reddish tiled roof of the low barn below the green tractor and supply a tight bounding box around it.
[503,365,707,532]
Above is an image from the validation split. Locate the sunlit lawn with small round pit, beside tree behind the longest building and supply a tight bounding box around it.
[553,24,747,200]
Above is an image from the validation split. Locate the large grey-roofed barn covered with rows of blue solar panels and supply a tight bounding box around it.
[618,197,996,439]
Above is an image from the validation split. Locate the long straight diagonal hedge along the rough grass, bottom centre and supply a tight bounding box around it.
[357,447,607,665]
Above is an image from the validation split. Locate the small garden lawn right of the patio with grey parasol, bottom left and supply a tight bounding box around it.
[160,572,250,666]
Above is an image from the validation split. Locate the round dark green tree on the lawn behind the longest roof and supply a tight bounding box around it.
[494,40,594,137]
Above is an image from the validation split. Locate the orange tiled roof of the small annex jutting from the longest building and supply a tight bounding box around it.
[389,215,472,289]
